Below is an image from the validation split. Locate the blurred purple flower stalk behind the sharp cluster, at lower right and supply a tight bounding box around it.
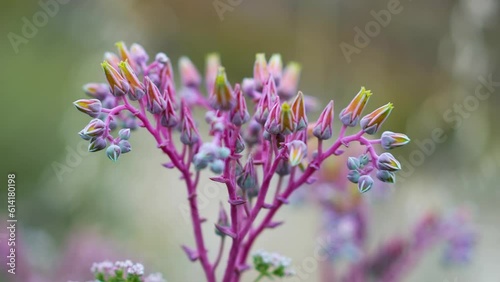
[312,161,477,282]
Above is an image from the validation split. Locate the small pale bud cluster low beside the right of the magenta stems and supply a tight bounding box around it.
[253,250,295,281]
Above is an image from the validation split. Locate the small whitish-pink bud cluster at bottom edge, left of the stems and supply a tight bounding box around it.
[85,260,166,282]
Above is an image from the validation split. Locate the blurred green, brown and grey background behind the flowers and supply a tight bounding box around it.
[0,0,500,282]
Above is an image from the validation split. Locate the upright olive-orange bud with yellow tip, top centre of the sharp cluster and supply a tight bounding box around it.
[210,67,236,111]
